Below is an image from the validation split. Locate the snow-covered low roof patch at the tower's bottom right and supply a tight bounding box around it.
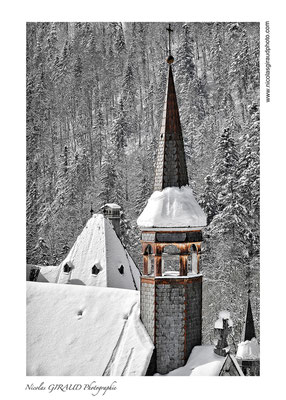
[155,345,225,376]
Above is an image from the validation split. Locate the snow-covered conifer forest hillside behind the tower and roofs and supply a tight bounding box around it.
[27,23,259,344]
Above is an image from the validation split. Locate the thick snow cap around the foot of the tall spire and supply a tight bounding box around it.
[137,186,207,228]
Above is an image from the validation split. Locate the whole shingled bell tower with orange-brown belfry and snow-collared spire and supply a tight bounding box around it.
[137,28,206,374]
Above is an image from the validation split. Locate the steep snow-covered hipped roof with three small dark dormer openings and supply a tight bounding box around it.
[57,214,140,290]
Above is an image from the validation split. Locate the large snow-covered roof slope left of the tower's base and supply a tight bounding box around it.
[27,282,153,376]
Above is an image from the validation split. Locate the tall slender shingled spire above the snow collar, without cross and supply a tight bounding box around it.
[154,64,189,191]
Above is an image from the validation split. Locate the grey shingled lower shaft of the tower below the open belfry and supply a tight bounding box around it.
[140,275,202,374]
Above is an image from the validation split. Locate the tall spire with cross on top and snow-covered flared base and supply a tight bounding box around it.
[137,25,207,230]
